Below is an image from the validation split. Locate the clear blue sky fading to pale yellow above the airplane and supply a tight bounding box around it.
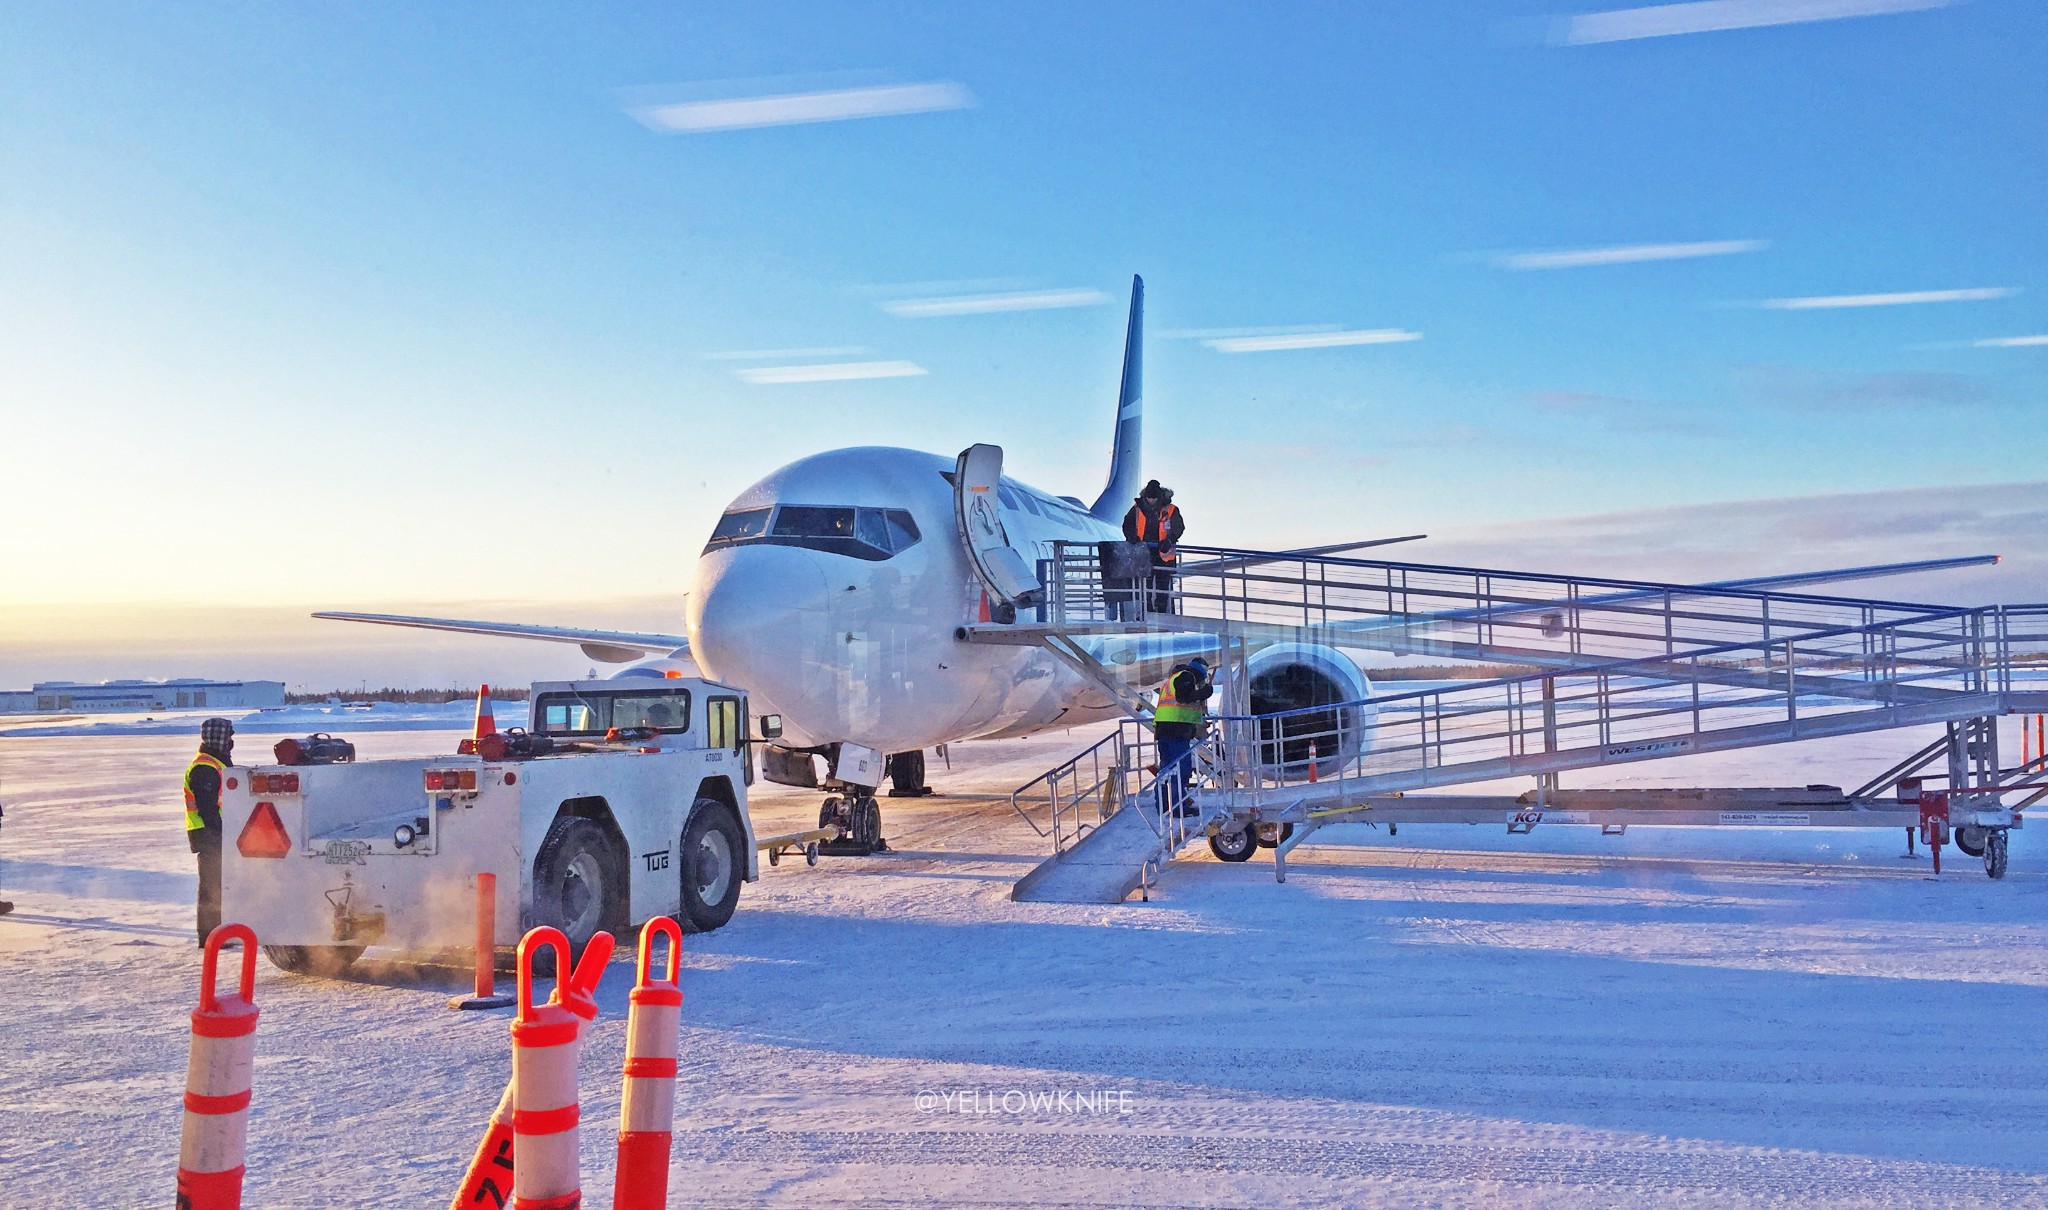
[0,0,2048,679]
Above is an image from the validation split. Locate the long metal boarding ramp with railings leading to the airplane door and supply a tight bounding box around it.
[963,543,2048,903]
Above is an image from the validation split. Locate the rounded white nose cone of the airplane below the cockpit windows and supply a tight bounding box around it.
[688,547,836,712]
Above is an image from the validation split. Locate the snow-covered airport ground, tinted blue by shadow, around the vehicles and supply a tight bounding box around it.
[0,723,2048,1208]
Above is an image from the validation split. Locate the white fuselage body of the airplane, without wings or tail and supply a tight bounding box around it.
[686,446,1163,753]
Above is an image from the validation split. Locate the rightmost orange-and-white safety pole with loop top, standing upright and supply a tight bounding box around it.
[612,915,682,1210]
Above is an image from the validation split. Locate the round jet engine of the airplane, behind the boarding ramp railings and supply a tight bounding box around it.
[1245,643,1378,782]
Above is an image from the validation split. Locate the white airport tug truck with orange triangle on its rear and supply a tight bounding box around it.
[221,674,772,975]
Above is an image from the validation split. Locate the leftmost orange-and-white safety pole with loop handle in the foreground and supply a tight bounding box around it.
[178,923,258,1210]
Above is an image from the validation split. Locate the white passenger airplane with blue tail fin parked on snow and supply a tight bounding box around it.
[313,276,1998,854]
